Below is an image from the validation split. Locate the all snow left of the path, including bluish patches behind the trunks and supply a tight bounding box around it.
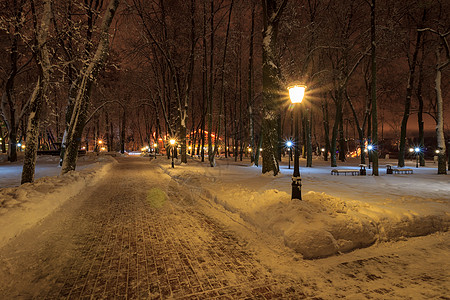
[0,155,112,247]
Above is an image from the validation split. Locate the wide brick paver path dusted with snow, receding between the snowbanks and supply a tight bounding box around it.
[0,159,298,299]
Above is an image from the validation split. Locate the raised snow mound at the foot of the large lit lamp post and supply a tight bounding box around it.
[210,186,450,258]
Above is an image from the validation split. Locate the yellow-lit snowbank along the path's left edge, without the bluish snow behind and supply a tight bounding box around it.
[0,157,115,247]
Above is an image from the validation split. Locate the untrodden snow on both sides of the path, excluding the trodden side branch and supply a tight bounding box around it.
[0,156,450,259]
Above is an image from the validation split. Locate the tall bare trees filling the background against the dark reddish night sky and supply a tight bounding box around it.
[0,0,450,182]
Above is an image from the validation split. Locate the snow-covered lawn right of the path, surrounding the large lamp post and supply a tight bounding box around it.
[160,160,450,259]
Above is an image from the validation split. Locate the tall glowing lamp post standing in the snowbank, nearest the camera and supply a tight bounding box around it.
[288,84,306,200]
